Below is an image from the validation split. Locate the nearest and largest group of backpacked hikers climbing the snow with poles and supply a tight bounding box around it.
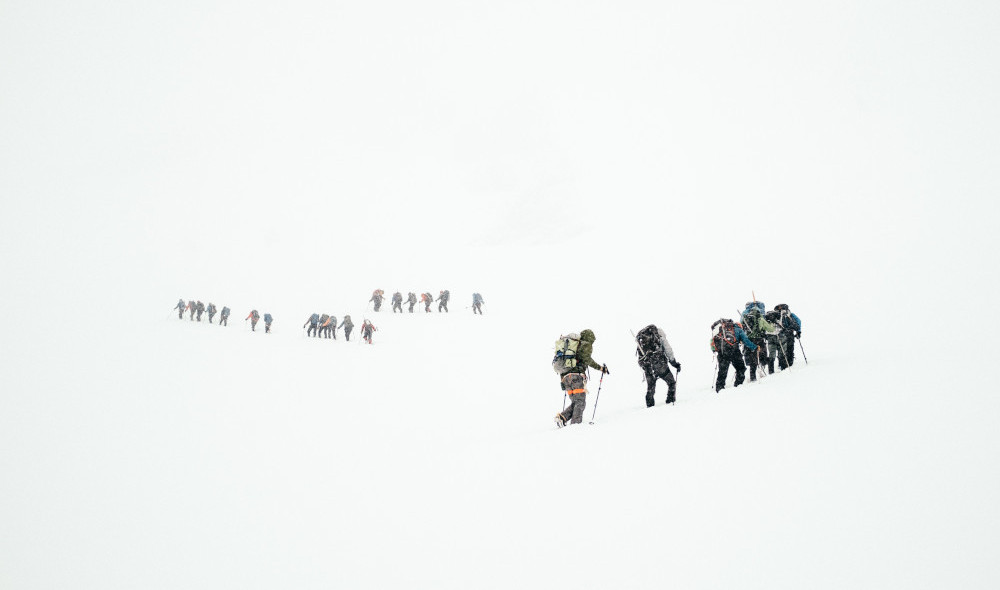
[552,298,805,428]
